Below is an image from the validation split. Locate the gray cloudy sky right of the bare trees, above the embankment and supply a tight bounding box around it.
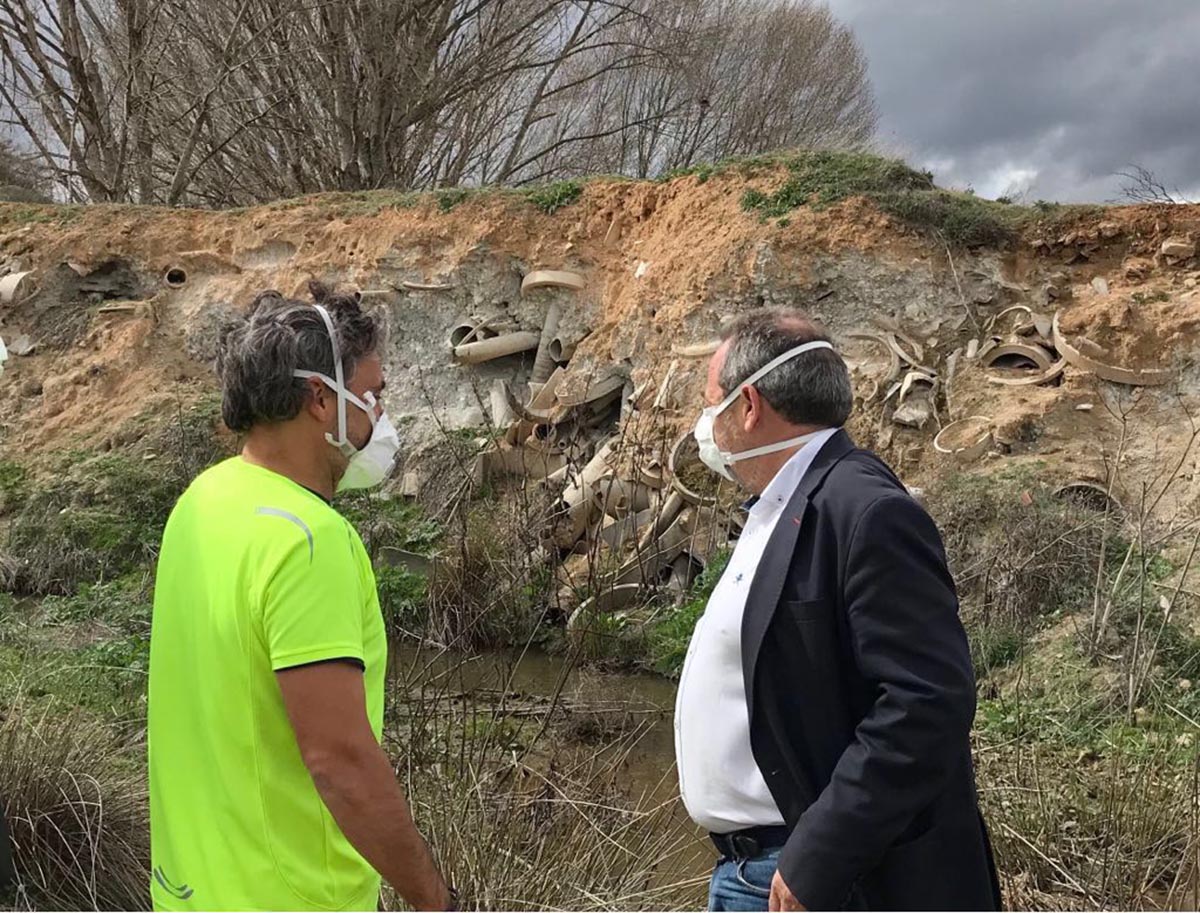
[828,0,1200,202]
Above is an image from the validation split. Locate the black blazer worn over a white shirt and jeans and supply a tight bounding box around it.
[742,431,1000,909]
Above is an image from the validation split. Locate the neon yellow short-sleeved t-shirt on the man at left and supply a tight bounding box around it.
[148,457,388,909]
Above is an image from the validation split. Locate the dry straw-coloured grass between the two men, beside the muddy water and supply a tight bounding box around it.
[389,656,707,909]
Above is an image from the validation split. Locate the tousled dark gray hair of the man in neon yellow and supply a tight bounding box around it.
[217,282,380,433]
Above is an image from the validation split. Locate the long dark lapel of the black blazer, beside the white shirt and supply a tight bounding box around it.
[742,431,854,716]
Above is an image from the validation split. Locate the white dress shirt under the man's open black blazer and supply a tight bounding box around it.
[674,428,838,834]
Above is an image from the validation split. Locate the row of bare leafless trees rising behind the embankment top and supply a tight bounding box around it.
[0,0,875,206]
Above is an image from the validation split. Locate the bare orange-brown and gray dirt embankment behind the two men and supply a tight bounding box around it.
[0,164,1200,523]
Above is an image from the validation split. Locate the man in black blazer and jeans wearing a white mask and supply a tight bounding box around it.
[676,310,1000,909]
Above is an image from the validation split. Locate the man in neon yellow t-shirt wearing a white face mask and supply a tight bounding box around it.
[148,288,452,909]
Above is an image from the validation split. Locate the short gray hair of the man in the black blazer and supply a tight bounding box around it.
[718,307,854,428]
